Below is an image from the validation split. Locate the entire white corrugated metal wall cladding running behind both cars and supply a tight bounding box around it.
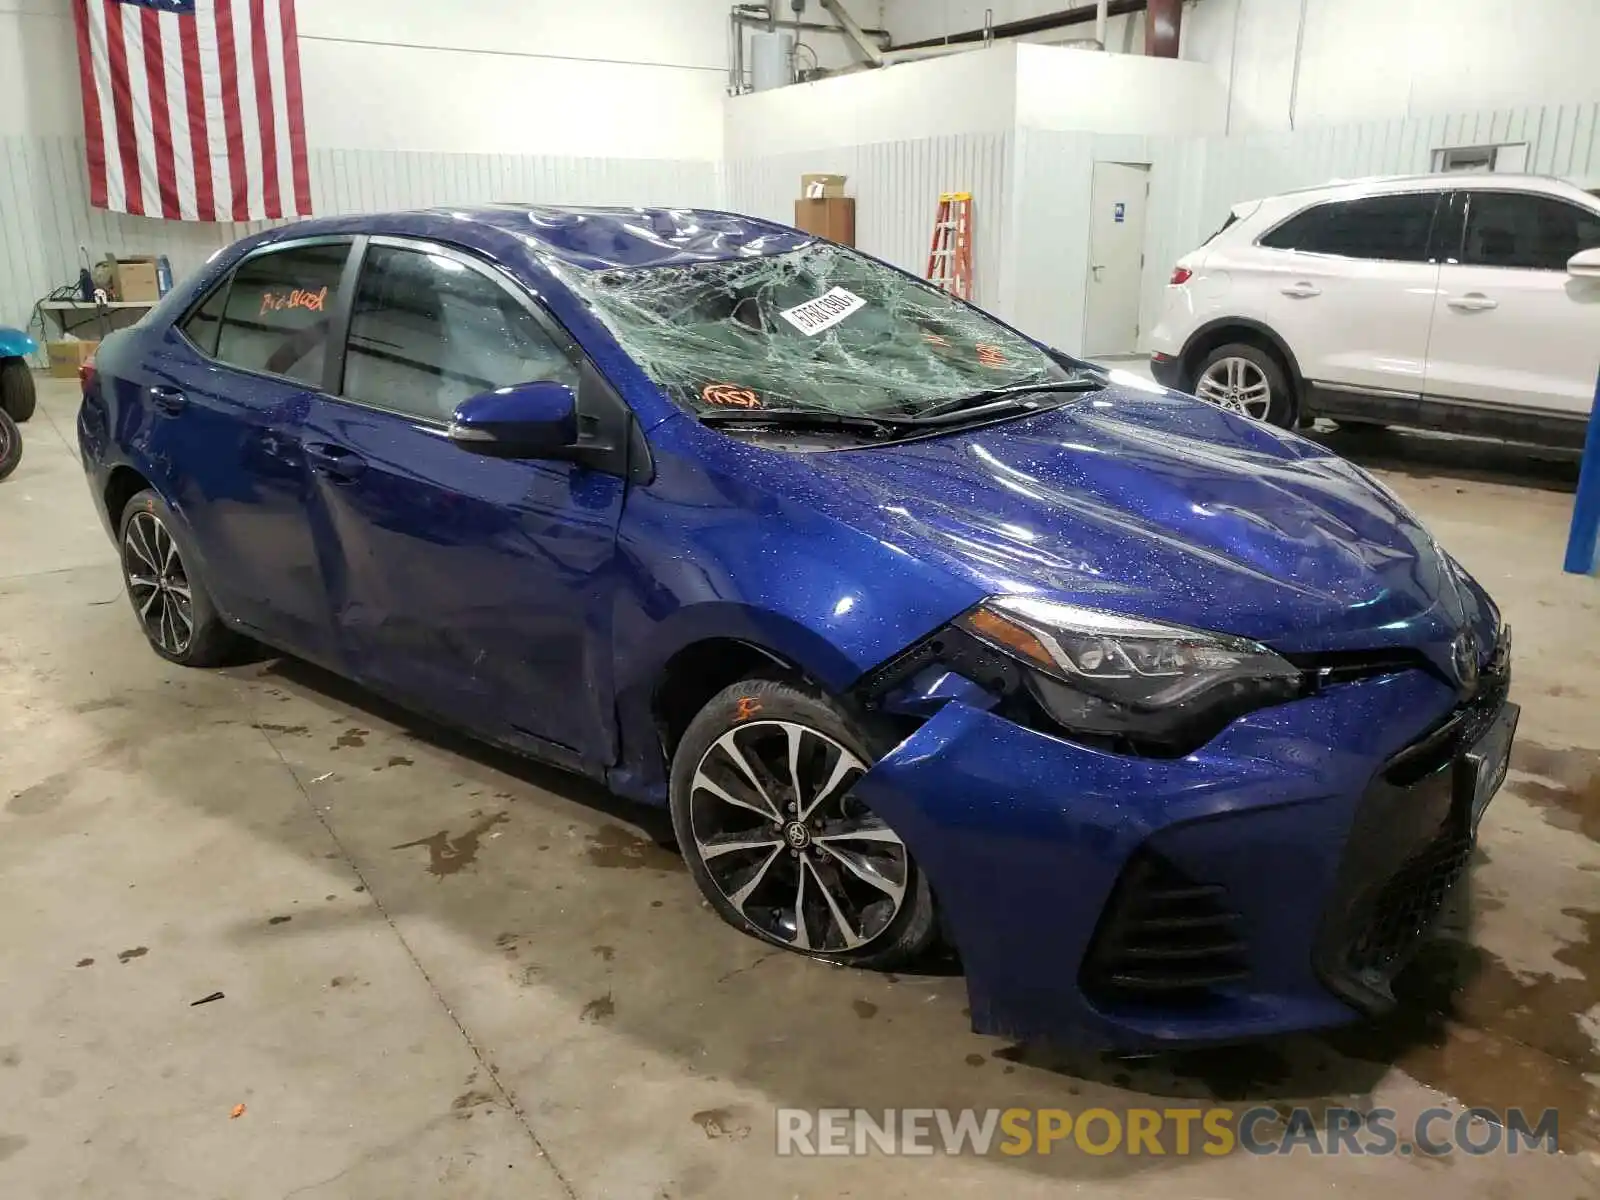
[18,104,1600,366]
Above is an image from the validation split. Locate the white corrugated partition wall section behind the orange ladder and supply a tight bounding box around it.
[723,134,1013,315]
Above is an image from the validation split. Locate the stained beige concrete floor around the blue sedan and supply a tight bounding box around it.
[9,371,1600,1200]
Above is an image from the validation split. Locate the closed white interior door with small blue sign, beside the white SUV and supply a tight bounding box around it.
[1083,163,1150,357]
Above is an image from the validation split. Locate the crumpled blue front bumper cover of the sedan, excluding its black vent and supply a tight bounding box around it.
[856,670,1458,1050]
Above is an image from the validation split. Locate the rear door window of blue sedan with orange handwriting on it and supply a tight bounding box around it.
[211,242,350,386]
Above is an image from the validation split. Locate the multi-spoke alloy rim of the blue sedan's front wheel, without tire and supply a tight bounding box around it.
[690,720,910,954]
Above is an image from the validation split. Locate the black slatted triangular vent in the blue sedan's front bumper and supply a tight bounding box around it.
[1082,850,1248,1003]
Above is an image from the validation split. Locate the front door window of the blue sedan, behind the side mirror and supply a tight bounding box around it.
[341,245,578,421]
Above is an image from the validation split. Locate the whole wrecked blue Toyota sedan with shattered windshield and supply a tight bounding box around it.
[78,205,1517,1050]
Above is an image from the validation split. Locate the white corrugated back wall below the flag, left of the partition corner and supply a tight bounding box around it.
[0,138,722,361]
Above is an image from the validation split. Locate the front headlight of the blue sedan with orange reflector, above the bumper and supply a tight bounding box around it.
[955,595,1304,754]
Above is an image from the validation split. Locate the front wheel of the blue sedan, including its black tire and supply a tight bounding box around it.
[670,680,938,970]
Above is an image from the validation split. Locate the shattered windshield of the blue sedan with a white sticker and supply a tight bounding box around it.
[562,243,1074,416]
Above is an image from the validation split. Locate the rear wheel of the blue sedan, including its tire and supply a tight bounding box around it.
[117,488,238,667]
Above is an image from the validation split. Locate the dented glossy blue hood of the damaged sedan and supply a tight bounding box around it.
[803,387,1496,667]
